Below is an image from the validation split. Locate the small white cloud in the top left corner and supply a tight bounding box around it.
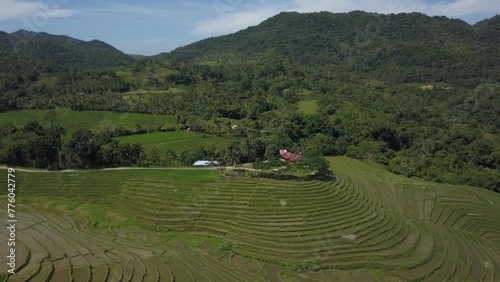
[0,0,76,21]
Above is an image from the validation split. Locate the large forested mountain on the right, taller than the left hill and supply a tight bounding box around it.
[161,12,500,86]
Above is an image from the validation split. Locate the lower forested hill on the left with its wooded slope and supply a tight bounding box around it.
[0,30,133,105]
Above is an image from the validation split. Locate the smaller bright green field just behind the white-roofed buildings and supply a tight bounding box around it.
[117,130,229,153]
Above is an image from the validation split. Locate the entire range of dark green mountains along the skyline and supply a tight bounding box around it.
[0,11,500,87]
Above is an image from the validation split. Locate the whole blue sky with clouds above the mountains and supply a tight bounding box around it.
[0,0,500,55]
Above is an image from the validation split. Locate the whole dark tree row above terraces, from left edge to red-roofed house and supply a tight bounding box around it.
[0,111,333,180]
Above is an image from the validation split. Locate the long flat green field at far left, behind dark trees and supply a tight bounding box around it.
[0,109,175,134]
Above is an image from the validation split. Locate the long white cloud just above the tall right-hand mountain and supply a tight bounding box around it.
[192,0,500,37]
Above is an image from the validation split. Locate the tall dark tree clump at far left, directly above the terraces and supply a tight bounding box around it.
[0,115,144,170]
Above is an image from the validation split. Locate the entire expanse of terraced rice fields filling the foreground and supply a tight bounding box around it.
[0,157,500,282]
